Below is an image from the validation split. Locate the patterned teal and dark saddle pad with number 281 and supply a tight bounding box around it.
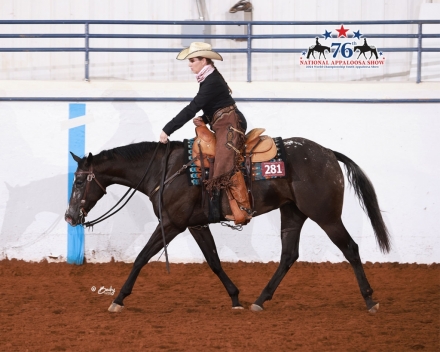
[183,137,286,186]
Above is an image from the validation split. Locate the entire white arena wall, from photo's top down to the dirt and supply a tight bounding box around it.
[0,0,440,263]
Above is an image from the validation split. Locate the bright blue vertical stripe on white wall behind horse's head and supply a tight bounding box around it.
[67,104,86,265]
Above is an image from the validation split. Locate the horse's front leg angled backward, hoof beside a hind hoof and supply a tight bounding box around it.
[188,226,243,309]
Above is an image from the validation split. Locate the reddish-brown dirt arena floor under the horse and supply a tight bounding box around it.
[0,260,440,351]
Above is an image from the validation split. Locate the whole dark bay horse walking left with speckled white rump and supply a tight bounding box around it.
[65,138,390,312]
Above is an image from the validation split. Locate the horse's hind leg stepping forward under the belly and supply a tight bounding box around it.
[251,203,307,311]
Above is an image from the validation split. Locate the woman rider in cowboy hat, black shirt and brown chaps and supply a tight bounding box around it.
[159,42,252,224]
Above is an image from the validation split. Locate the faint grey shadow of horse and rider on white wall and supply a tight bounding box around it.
[0,95,157,260]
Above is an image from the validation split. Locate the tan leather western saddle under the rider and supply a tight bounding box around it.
[192,125,277,167]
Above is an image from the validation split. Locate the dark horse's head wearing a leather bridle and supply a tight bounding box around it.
[64,152,106,226]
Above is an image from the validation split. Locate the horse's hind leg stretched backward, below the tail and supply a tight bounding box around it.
[319,219,379,313]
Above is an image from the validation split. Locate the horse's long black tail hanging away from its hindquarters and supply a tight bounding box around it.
[333,151,391,253]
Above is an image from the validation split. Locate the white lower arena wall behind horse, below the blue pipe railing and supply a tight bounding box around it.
[0,80,440,263]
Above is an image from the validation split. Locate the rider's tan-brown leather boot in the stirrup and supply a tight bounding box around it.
[225,171,252,225]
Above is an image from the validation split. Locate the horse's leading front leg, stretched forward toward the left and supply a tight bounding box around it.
[108,224,182,312]
